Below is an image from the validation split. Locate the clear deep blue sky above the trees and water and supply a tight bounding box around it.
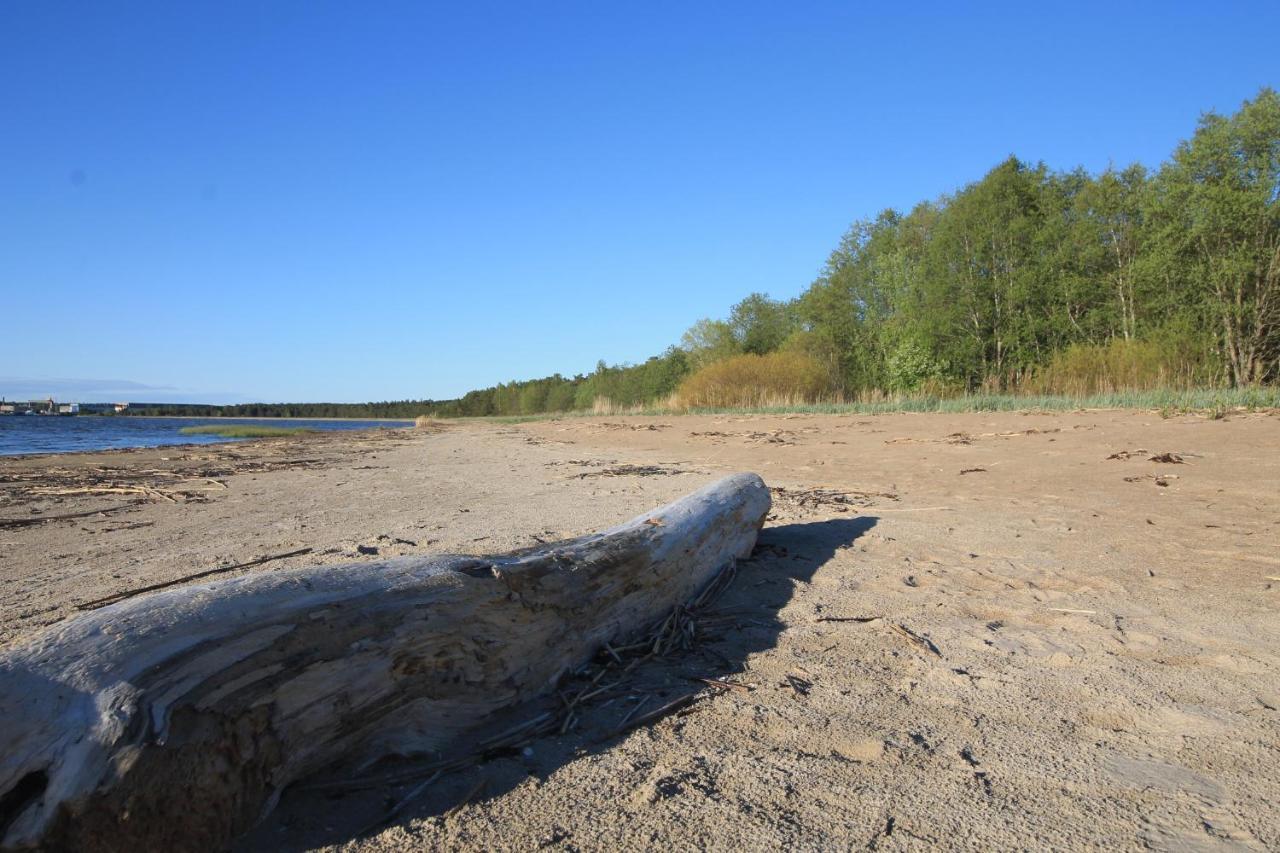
[0,0,1280,401]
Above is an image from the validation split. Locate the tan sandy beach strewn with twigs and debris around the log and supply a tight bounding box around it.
[0,411,1280,850]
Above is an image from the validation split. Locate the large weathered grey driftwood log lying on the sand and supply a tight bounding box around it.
[0,474,769,849]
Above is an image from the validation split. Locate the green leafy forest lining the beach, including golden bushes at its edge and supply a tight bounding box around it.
[127,88,1280,416]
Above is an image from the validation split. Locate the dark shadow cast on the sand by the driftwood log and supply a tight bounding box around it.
[236,516,878,850]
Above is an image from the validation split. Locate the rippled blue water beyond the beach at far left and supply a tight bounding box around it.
[0,415,411,456]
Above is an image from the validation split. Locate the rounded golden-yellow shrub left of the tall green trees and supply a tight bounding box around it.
[678,351,833,409]
